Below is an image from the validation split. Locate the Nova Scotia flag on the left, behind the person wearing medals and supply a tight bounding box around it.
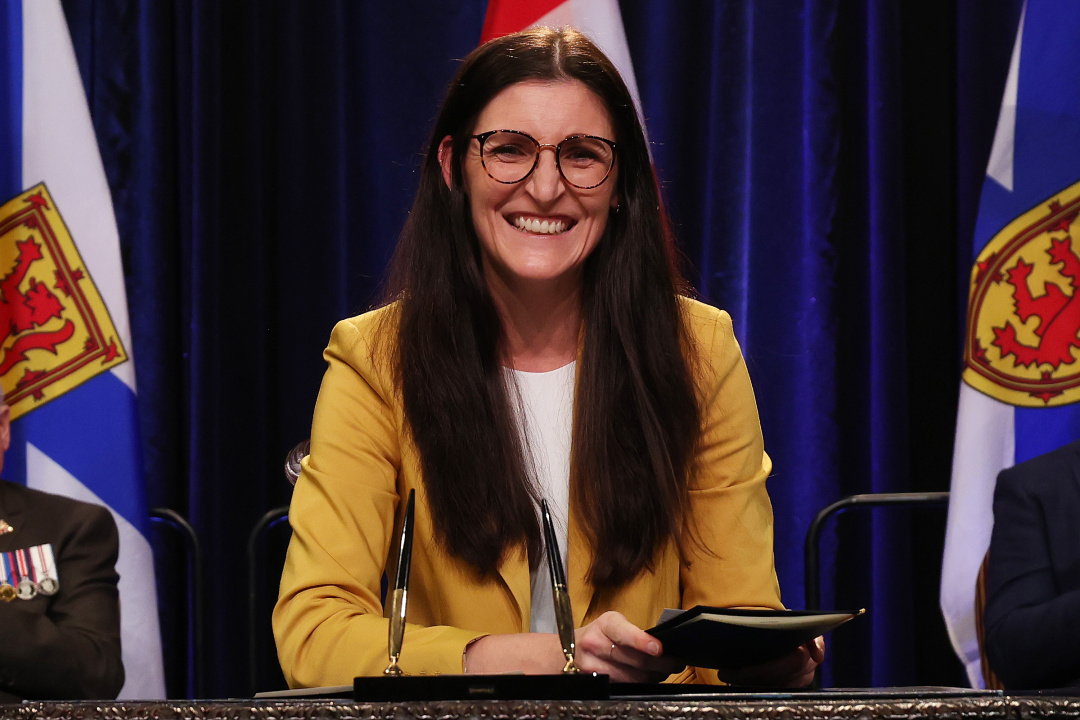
[0,0,164,698]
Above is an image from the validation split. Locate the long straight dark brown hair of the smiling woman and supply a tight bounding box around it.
[387,28,701,588]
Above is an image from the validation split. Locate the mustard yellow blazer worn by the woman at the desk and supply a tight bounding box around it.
[273,300,781,688]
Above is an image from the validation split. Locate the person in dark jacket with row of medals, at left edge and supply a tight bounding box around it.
[0,393,124,703]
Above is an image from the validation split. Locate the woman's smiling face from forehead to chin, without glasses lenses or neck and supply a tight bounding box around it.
[440,80,618,290]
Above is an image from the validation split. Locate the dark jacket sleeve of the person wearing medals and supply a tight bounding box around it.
[0,503,124,699]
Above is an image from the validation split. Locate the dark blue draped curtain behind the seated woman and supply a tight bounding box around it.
[65,0,1020,696]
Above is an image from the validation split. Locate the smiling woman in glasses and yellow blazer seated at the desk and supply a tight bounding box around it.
[274,29,822,687]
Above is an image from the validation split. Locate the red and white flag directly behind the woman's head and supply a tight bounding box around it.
[481,0,645,124]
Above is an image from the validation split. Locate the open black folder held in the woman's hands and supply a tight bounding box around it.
[646,606,865,669]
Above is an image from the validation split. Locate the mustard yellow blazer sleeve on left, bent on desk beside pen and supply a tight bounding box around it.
[273,316,483,688]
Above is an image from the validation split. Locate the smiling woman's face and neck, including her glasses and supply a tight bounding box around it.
[440,80,618,343]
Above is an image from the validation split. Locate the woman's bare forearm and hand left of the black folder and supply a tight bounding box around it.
[464,611,684,682]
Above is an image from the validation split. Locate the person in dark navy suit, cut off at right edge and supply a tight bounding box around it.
[983,440,1080,689]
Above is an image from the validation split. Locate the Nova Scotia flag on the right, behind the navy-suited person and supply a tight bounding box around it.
[941,0,1080,688]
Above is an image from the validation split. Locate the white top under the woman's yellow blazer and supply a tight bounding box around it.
[508,363,577,633]
